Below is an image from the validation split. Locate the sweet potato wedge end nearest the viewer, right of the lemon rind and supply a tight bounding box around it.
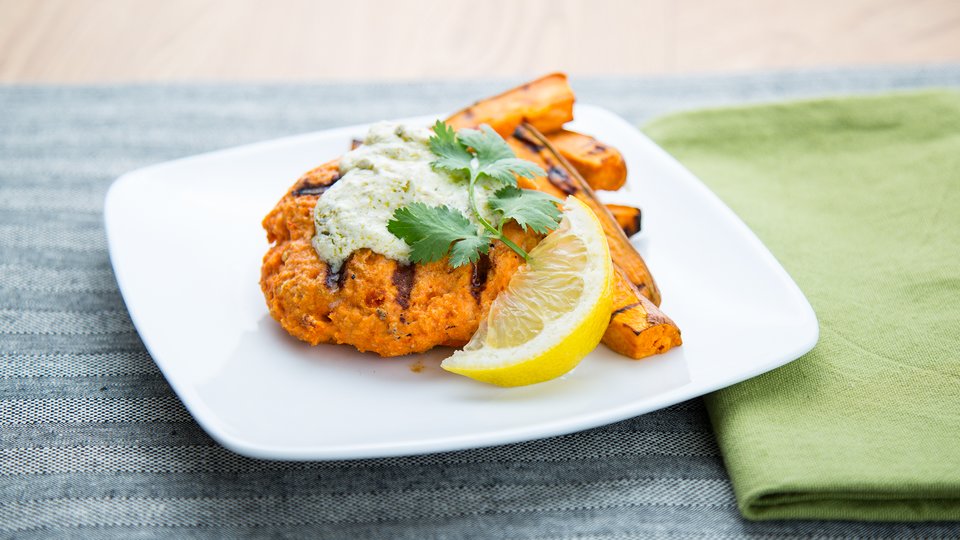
[603,268,683,359]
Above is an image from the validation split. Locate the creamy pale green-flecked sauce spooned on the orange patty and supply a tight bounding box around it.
[313,122,493,272]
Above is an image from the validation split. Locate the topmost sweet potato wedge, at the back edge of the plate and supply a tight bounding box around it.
[446,73,574,137]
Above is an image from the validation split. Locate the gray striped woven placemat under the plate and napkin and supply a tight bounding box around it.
[0,66,960,538]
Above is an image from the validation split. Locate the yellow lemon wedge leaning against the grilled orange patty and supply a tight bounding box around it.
[441,196,613,386]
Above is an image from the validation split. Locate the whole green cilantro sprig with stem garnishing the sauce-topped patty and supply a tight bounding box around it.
[387,120,561,268]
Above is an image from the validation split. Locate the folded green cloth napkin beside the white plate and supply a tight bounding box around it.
[645,91,960,520]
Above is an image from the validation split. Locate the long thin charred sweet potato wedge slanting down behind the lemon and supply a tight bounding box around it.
[513,123,660,305]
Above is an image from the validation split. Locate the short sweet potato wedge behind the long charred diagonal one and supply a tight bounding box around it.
[541,130,629,191]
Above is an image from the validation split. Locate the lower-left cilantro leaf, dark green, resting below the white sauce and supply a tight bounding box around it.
[387,202,490,268]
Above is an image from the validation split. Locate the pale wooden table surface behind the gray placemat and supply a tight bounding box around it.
[0,0,960,83]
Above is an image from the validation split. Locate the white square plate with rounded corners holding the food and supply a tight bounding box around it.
[104,105,818,460]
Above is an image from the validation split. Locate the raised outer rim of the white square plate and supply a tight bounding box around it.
[109,103,820,461]
